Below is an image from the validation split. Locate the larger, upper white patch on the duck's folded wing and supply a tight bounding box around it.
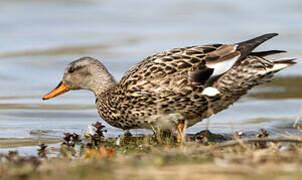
[206,55,240,76]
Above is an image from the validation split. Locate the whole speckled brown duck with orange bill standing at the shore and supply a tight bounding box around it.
[43,33,296,141]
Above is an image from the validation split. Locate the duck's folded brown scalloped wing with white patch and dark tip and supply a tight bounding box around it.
[120,33,278,91]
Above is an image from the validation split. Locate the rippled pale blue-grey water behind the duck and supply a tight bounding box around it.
[0,0,302,154]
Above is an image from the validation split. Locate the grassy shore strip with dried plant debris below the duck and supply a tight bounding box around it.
[0,126,302,180]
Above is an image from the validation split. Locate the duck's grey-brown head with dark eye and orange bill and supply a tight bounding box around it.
[43,57,116,100]
